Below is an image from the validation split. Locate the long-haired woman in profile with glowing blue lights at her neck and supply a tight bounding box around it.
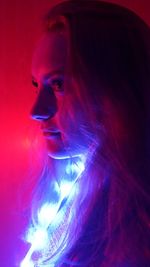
[21,0,150,267]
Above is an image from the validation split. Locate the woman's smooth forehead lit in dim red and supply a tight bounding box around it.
[32,32,67,79]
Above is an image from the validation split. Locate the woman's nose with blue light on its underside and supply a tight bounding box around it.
[31,88,57,121]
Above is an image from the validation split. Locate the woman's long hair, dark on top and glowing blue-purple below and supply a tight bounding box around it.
[21,0,150,267]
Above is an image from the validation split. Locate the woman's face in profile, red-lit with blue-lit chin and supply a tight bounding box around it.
[31,32,89,159]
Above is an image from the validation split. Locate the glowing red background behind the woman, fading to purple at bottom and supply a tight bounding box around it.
[0,0,150,267]
